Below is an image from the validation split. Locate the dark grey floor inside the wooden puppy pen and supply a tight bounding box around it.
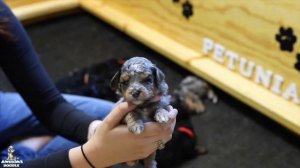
[2,12,300,168]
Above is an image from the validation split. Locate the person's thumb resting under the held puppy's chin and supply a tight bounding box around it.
[103,102,135,129]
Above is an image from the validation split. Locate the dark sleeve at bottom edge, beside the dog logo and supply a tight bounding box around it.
[21,151,72,168]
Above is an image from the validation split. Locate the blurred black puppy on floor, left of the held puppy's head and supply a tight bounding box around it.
[55,58,125,102]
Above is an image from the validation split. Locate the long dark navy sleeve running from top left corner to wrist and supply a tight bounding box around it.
[0,0,96,143]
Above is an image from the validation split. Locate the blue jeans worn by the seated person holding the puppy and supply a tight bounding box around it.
[0,91,114,160]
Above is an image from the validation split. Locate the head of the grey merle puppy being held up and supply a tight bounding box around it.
[111,57,167,105]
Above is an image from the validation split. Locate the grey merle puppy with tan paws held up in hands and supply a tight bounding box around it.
[111,57,171,168]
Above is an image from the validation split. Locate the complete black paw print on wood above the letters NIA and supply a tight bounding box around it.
[276,27,297,52]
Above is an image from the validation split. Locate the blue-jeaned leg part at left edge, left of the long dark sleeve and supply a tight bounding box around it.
[0,92,50,147]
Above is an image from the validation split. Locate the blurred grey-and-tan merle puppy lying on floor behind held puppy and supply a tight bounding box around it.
[172,76,218,114]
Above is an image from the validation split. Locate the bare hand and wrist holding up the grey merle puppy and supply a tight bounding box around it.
[69,102,177,167]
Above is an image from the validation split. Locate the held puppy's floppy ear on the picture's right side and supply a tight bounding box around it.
[152,67,168,94]
